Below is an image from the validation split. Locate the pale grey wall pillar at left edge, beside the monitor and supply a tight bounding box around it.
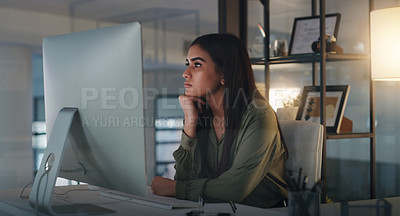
[0,45,33,189]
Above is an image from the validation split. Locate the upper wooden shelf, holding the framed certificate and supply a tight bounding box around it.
[251,54,370,65]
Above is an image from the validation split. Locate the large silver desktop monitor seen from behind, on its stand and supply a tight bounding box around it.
[29,22,146,212]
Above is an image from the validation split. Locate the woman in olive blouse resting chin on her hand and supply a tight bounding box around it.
[151,34,287,208]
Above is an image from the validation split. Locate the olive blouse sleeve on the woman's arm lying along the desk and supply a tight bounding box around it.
[176,102,285,202]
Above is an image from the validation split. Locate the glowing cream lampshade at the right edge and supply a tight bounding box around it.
[371,7,400,81]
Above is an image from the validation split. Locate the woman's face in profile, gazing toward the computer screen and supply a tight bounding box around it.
[182,45,224,97]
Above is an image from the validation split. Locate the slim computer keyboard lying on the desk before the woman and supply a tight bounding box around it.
[100,190,198,209]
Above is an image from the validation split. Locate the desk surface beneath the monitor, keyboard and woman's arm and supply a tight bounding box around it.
[0,185,400,216]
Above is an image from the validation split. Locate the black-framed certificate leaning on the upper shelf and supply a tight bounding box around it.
[289,13,341,55]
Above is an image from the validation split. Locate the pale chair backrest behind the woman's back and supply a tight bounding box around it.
[279,120,324,188]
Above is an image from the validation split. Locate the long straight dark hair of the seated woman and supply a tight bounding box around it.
[191,34,284,177]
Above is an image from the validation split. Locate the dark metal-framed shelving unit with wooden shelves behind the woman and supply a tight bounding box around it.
[255,0,376,199]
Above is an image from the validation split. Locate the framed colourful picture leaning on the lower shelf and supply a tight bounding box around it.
[296,85,350,133]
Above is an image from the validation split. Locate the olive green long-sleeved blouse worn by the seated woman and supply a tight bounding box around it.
[173,99,287,208]
